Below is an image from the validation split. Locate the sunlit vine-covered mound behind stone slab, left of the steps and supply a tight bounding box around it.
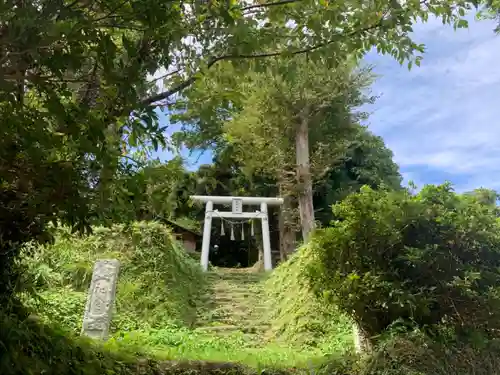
[19,222,204,333]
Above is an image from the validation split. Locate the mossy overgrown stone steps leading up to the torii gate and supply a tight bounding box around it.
[196,268,269,341]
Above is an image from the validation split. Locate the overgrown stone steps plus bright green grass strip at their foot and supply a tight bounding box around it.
[99,269,349,370]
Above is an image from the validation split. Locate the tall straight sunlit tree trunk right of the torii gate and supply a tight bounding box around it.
[295,107,315,242]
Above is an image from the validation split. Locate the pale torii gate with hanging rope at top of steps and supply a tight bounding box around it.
[191,195,283,271]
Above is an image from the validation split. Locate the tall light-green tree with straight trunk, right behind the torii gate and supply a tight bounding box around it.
[225,58,371,241]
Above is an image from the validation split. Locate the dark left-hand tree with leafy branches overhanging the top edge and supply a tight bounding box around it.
[0,0,476,303]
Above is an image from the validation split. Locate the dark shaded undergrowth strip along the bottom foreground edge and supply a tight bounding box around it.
[0,313,500,375]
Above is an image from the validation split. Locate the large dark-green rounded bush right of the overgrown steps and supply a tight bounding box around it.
[308,184,500,344]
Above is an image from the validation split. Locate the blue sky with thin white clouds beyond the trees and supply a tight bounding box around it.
[154,13,500,191]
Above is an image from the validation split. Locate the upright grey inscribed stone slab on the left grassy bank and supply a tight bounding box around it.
[82,259,120,340]
